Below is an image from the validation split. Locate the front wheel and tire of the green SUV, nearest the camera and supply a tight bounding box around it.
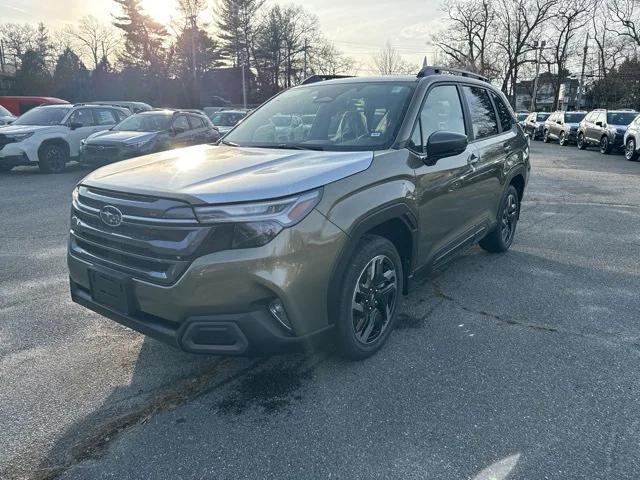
[336,235,403,360]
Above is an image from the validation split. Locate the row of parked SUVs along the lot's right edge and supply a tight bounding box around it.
[521,109,640,160]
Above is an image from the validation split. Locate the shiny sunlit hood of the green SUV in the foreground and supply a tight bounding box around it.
[81,145,373,204]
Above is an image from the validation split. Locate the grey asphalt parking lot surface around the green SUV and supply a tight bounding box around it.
[0,142,640,480]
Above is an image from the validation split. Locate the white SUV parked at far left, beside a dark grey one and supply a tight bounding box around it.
[0,105,131,173]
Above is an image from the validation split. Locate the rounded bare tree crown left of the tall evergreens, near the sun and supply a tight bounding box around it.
[66,15,123,69]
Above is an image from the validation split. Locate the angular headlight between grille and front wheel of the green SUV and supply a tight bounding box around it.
[195,190,322,249]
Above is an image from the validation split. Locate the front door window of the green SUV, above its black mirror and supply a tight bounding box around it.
[420,85,466,146]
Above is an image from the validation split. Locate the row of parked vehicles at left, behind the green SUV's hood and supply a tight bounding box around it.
[0,97,248,173]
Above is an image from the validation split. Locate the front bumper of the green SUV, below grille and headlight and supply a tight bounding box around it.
[68,211,346,355]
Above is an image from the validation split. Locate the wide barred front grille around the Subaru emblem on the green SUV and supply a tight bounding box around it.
[69,186,215,285]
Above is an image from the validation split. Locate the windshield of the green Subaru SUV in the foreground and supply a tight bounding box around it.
[225,82,415,150]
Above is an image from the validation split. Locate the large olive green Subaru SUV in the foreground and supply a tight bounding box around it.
[68,67,530,358]
